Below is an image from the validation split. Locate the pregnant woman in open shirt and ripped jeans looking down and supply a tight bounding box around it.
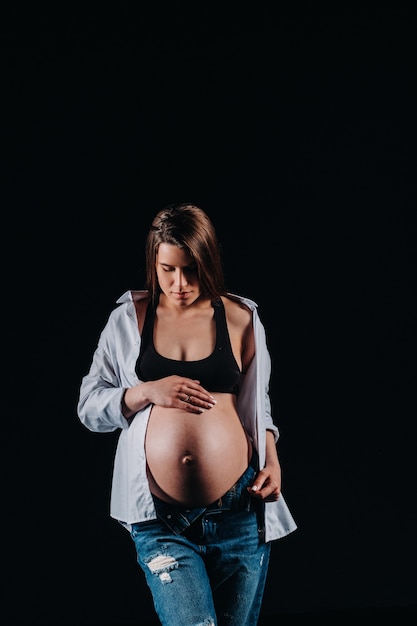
[78,204,296,626]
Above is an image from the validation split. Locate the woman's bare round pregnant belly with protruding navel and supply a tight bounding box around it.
[145,394,252,506]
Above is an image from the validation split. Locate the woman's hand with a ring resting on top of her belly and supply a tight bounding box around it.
[122,375,216,419]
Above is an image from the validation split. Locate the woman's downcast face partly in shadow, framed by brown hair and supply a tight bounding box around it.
[155,243,201,307]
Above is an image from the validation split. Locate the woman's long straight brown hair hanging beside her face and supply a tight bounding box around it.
[145,203,226,304]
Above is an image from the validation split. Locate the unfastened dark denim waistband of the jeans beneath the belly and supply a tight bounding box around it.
[152,449,259,535]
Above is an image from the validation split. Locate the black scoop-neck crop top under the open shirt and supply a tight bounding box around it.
[136,298,241,395]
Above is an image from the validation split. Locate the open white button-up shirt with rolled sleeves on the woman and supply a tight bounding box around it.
[78,291,297,541]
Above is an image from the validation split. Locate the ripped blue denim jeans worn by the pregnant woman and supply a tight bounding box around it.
[131,454,270,626]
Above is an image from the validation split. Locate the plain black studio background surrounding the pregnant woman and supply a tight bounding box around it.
[1,2,417,625]
